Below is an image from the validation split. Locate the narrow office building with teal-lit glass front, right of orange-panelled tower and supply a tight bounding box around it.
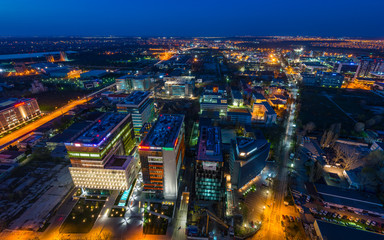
[195,126,225,201]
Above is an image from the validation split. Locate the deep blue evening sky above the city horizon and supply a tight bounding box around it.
[0,0,384,37]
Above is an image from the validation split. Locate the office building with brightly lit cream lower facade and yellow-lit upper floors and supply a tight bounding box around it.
[65,113,140,190]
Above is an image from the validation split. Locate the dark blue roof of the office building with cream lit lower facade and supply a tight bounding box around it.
[74,113,127,144]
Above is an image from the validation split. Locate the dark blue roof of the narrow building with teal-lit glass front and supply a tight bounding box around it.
[197,126,223,162]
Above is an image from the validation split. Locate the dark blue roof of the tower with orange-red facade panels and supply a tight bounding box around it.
[139,114,184,149]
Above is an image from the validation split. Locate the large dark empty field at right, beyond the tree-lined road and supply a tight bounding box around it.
[299,87,384,134]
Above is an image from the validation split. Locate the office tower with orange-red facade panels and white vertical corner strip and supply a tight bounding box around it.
[139,114,185,199]
